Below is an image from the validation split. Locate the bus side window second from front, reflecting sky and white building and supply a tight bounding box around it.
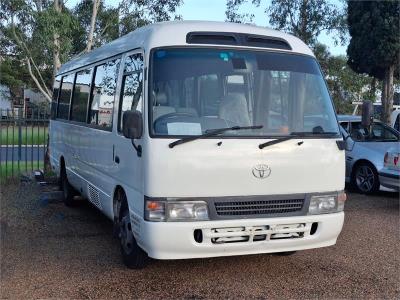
[89,59,120,129]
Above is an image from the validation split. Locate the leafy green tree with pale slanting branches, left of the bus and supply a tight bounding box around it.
[0,0,75,101]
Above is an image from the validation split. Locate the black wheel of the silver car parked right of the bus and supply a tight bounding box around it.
[352,162,380,194]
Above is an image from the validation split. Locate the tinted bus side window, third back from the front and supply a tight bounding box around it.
[71,70,92,122]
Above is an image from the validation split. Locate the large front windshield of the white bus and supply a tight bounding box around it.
[149,48,339,137]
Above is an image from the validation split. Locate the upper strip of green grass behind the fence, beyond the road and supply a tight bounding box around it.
[0,126,48,145]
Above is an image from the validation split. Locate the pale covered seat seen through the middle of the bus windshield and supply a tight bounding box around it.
[219,93,250,126]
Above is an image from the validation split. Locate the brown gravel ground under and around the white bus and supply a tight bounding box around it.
[0,183,400,299]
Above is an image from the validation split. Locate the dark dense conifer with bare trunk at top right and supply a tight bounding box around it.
[347,1,400,124]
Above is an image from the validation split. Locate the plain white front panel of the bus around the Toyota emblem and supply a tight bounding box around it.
[145,138,345,197]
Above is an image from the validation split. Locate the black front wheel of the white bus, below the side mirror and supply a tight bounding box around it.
[119,193,148,269]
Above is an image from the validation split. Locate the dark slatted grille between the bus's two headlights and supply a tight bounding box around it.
[215,199,304,216]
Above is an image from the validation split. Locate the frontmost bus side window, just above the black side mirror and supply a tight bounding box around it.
[118,54,143,131]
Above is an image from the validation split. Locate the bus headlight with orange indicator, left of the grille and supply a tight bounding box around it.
[145,200,209,222]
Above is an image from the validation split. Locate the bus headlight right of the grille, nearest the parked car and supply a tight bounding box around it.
[308,192,346,215]
